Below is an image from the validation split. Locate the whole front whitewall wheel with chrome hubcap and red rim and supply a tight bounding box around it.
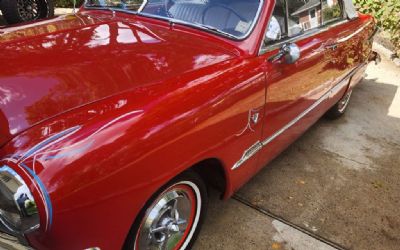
[124,172,208,250]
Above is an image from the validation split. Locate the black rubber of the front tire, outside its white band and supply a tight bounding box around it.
[123,171,208,250]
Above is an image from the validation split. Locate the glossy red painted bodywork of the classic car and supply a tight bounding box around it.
[0,1,374,249]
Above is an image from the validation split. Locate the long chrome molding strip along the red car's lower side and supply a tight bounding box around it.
[231,64,365,170]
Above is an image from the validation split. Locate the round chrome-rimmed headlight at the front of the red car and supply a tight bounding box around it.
[0,165,40,234]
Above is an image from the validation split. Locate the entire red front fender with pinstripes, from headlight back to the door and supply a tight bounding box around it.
[1,54,265,249]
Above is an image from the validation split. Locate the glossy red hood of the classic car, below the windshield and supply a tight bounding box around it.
[0,11,234,145]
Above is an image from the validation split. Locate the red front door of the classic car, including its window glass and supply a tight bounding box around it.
[258,0,333,170]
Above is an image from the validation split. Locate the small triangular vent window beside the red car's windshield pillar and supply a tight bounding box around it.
[264,0,287,44]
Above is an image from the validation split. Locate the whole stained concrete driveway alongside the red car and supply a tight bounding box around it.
[195,47,400,250]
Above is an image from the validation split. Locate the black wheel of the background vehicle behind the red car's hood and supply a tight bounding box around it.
[0,0,54,24]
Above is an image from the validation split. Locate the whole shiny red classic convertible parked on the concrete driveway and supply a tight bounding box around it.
[0,0,376,250]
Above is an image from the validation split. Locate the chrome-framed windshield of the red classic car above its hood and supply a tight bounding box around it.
[85,0,262,38]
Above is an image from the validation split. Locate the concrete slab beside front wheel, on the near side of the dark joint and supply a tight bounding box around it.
[194,192,335,250]
